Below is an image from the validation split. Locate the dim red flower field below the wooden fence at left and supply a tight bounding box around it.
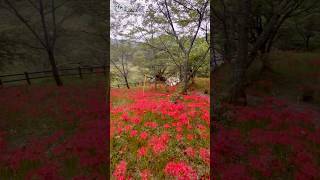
[0,82,108,180]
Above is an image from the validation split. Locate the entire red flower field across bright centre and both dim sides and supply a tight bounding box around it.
[0,79,320,180]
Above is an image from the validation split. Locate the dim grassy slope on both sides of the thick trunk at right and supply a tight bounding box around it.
[214,51,320,105]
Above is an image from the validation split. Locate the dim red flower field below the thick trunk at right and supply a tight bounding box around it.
[213,98,320,180]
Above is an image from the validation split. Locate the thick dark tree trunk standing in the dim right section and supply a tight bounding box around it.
[230,0,251,105]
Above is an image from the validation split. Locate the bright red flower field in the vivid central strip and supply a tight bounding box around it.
[111,88,210,180]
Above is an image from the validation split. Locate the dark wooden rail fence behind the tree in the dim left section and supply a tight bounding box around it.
[0,66,106,86]
